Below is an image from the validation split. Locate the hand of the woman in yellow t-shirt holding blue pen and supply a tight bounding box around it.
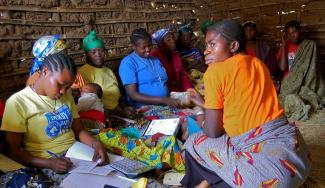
[48,157,73,173]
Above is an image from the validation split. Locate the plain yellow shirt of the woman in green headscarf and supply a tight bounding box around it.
[78,64,121,110]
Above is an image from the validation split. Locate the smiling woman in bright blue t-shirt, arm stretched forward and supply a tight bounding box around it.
[119,28,180,108]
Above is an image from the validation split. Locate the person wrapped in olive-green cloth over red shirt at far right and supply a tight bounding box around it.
[278,20,325,121]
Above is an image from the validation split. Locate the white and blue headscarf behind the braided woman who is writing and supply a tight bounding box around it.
[29,35,67,75]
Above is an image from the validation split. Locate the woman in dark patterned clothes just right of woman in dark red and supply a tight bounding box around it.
[176,24,207,72]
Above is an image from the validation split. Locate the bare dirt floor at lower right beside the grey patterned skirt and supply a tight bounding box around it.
[296,111,325,188]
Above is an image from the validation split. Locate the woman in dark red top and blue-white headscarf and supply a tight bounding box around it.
[150,29,192,91]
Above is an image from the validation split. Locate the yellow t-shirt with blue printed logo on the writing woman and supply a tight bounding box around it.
[1,86,79,158]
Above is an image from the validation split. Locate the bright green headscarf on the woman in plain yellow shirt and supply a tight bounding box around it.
[82,30,105,52]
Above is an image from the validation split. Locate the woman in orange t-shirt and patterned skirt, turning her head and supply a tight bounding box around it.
[182,20,310,187]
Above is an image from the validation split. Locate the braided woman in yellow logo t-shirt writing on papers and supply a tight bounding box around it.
[1,53,108,183]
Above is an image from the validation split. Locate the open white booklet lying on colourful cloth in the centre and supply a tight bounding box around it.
[145,118,180,136]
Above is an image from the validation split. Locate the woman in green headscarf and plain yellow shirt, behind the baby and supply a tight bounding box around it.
[79,30,121,110]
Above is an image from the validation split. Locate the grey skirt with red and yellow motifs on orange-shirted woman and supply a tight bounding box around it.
[184,118,311,187]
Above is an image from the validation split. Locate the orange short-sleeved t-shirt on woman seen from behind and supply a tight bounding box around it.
[204,54,283,137]
